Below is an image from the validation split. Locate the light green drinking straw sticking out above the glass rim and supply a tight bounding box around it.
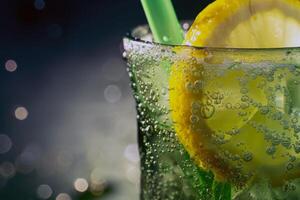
[141,0,183,44]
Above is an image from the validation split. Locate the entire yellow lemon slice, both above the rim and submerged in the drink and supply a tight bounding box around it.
[169,0,300,185]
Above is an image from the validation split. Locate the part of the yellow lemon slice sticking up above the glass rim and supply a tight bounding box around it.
[185,0,300,48]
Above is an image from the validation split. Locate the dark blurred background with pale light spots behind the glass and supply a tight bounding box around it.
[0,0,211,200]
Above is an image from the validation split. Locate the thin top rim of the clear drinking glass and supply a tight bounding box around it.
[123,23,300,52]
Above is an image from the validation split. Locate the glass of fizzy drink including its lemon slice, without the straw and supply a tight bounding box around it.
[124,0,300,200]
